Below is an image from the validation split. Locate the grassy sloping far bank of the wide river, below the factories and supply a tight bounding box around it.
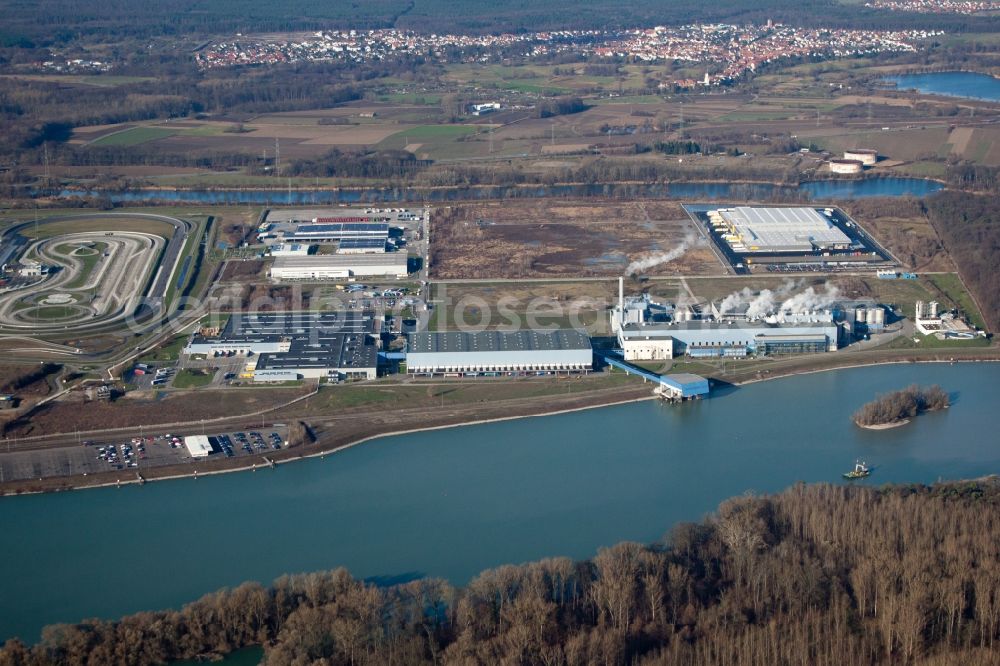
[0,349,1000,497]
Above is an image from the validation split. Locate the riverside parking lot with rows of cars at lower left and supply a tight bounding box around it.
[0,424,287,483]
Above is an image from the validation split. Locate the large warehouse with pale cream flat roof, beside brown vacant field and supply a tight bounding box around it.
[708,206,851,254]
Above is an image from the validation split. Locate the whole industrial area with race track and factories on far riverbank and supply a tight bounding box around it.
[0,192,989,492]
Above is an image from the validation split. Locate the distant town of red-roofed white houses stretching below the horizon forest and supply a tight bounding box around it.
[196,21,942,84]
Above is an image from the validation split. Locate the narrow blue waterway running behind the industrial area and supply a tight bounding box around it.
[58,177,944,205]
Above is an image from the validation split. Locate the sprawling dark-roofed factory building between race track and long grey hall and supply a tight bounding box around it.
[184,312,379,382]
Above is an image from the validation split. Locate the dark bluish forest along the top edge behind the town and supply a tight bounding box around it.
[0,0,1000,45]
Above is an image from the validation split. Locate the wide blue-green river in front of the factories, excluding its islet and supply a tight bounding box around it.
[0,364,1000,641]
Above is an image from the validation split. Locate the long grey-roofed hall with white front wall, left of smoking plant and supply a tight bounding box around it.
[406,329,594,377]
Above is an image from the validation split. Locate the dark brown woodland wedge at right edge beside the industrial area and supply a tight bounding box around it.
[927,192,1000,331]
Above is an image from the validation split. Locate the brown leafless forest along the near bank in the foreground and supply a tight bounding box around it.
[0,480,1000,666]
